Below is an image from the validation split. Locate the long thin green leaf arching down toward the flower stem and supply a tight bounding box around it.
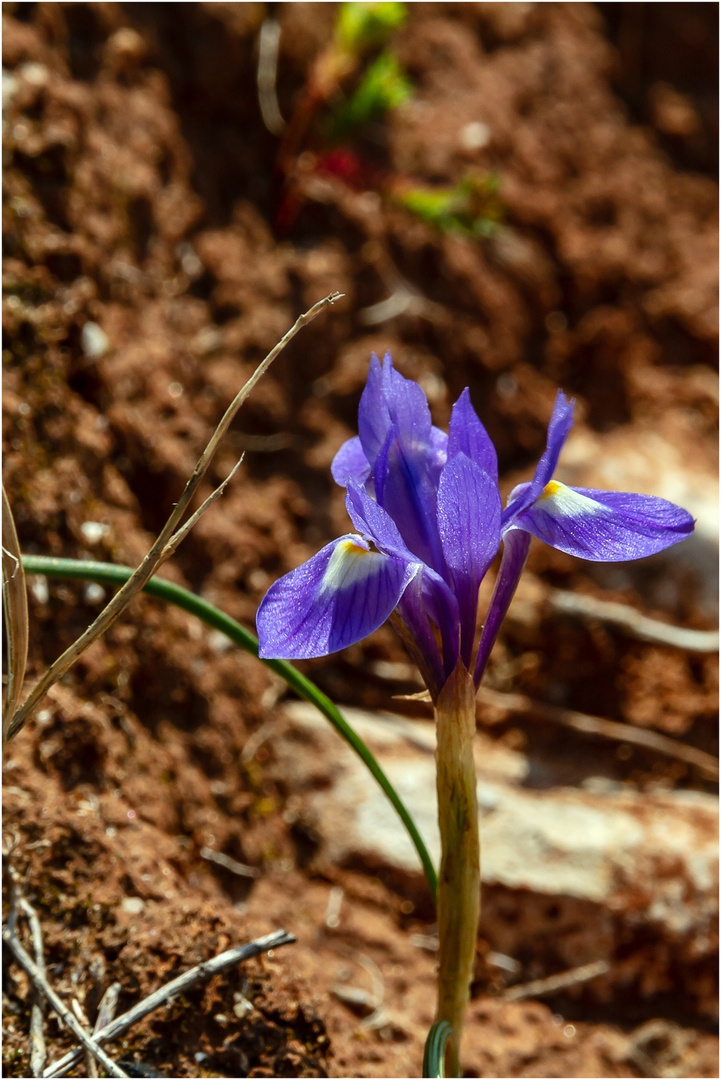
[23,555,437,901]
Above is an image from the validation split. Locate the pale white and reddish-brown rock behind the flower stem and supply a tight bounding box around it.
[273,702,718,994]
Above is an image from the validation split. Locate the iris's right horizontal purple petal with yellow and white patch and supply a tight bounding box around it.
[516,481,694,563]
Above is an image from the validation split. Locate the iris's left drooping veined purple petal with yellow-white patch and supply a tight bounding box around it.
[256,534,420,660]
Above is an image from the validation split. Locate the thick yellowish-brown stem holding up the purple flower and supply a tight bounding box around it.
[435,662,480,1077]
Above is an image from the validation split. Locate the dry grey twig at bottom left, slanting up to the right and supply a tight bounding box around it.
[43,930,296,1077]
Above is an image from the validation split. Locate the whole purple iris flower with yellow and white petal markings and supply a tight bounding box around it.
[257,354,694,700]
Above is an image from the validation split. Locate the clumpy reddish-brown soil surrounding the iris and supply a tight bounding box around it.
[3,3,718,1077]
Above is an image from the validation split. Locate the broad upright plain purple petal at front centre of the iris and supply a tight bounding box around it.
[438,453,501,667]
